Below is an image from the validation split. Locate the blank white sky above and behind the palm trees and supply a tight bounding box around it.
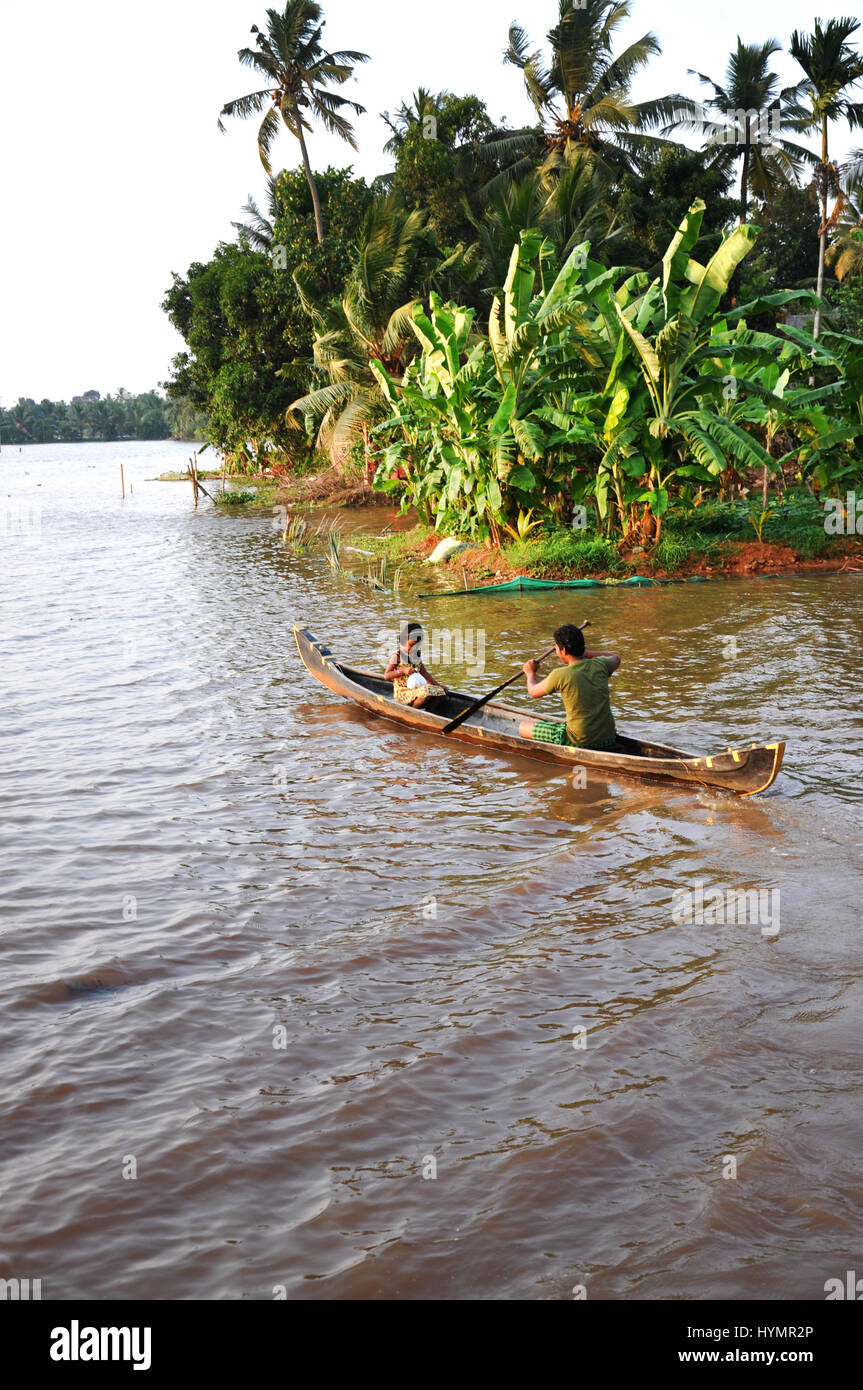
[0,0,863,406]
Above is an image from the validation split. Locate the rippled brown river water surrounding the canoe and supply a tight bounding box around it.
[0,443,863,1300]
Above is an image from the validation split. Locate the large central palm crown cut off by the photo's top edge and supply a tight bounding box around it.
[504,0,680,177]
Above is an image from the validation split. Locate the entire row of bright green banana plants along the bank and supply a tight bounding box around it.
[372,203,863,541]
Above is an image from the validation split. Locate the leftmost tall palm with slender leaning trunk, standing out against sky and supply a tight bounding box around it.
[218,0,368,242]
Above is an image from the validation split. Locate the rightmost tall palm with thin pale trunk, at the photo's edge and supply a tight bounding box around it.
[789,15,863,338]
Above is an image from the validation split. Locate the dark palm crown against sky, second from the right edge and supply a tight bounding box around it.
[663,35,810,224]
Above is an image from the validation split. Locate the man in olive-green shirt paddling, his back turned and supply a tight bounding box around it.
[518,623,620,749]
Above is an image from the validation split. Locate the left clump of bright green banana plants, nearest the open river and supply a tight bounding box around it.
[371,231,611,538]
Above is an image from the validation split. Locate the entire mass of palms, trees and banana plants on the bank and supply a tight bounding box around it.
[159,0,863,555]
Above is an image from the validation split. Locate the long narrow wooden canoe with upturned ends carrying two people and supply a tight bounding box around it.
[293,626,785,796]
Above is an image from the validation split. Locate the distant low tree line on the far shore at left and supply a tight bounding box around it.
[0,386,207,445]
